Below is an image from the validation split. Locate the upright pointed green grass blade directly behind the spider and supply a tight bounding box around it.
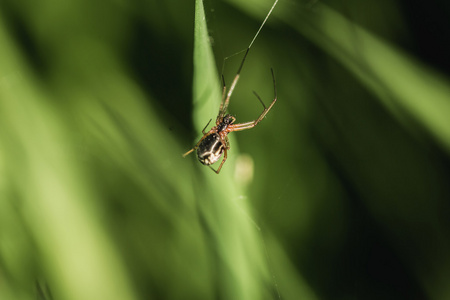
[188,0,269,299]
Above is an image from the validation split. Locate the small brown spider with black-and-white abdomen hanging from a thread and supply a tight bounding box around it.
[183,44,277,174]
